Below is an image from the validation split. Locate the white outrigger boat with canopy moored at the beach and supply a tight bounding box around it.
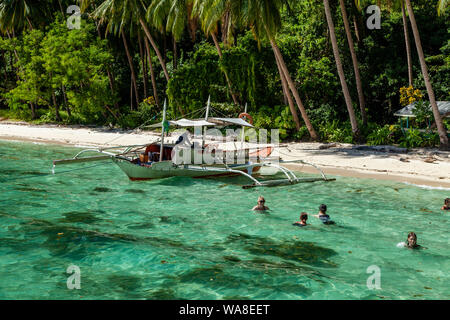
[53,99,334,188]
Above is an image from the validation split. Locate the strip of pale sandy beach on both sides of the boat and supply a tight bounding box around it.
[0,121,450,188]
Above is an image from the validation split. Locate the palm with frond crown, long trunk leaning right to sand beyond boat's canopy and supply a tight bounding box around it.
[237,0,318,140]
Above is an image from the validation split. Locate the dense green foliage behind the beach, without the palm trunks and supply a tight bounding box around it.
[0,0,450,146]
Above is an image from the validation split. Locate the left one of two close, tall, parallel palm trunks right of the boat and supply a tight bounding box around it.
[323,0,359,141]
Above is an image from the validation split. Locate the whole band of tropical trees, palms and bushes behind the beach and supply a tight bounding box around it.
[0,0,450,149]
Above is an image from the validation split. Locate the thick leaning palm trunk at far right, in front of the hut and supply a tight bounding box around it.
[406,0,449,150]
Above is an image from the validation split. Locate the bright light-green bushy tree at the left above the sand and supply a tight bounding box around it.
[0,18,116,123]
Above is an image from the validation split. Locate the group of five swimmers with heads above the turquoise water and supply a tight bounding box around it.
[252,196,450,249]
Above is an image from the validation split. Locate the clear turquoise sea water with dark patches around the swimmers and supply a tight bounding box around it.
[0,142,450,299]
